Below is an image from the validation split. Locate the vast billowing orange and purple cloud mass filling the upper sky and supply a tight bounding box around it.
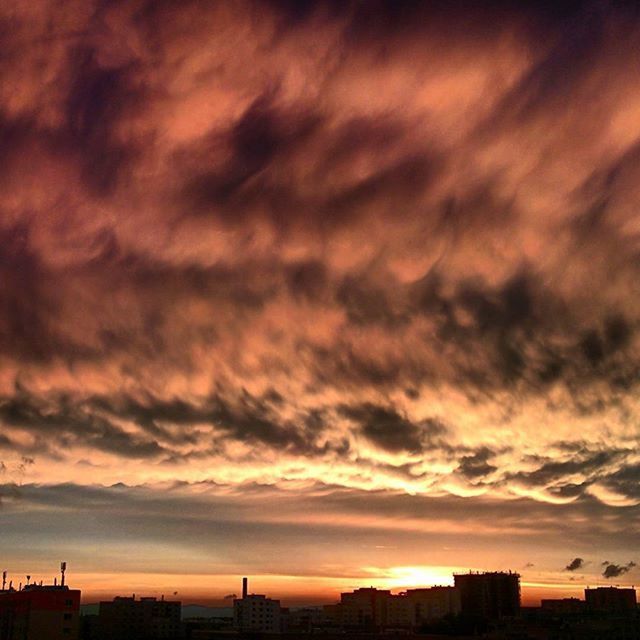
[0,0,640,528]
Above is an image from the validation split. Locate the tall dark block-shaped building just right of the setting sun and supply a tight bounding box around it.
[453,571,520,620]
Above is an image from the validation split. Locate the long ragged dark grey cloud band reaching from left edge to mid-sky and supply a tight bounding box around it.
[0,390,344,460]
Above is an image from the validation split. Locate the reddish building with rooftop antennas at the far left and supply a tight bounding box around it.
[0,567,80,640]
